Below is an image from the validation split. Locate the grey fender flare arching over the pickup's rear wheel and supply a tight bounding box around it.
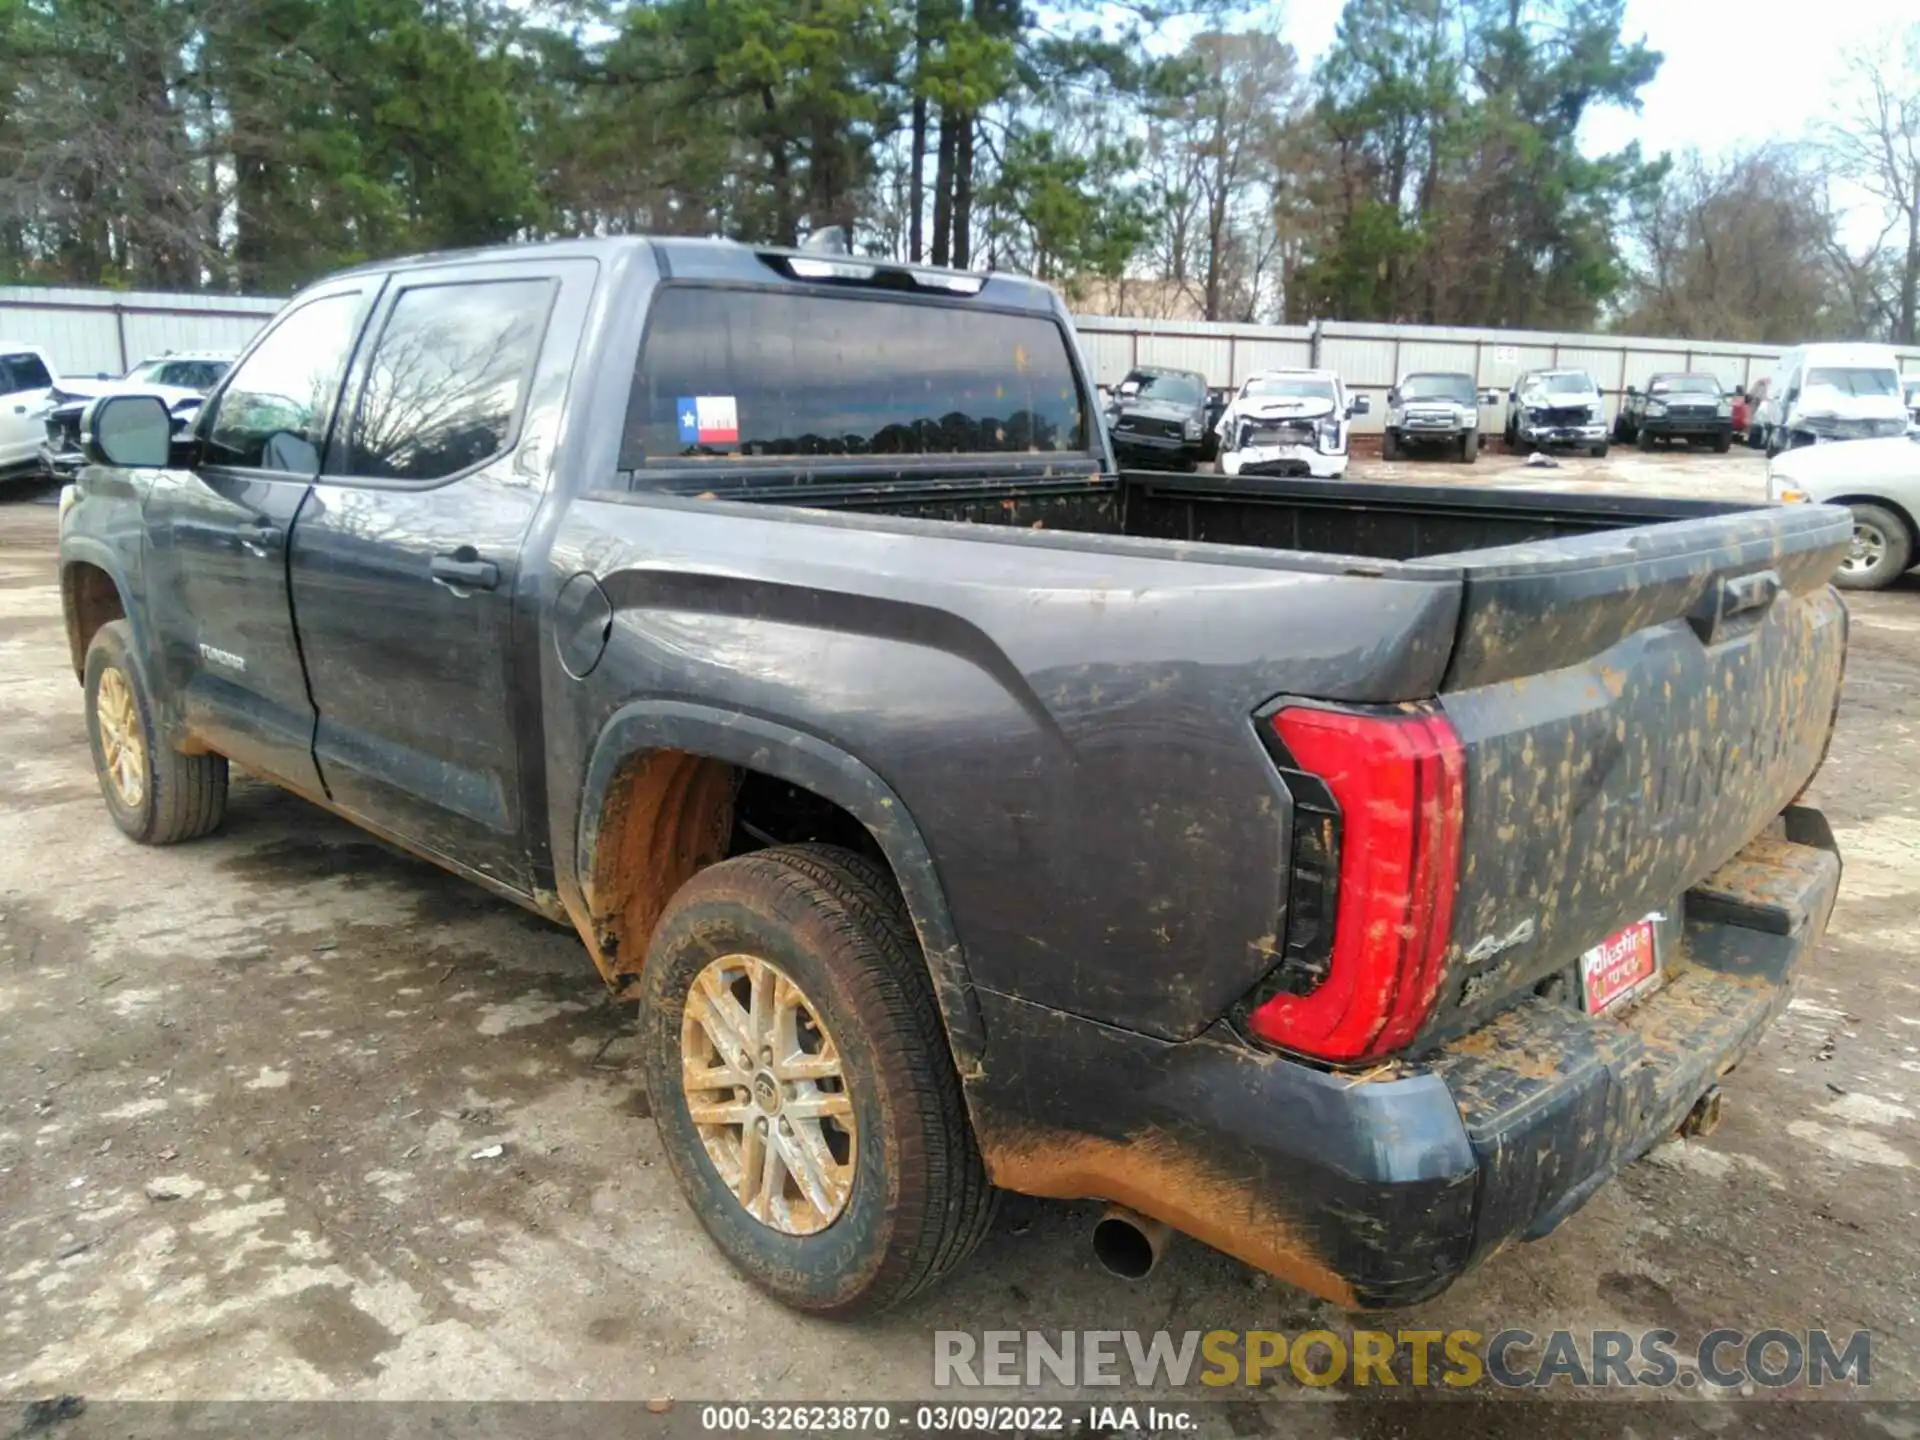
[574,701,987,1075]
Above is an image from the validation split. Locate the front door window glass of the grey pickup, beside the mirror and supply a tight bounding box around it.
[205,292,361,474]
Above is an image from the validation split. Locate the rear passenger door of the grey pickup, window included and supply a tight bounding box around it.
[290,259,595,893]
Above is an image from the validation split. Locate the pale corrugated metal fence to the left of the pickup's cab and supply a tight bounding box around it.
[0,286,280,374]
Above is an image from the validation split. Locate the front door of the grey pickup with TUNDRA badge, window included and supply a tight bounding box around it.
[144,276,378,793]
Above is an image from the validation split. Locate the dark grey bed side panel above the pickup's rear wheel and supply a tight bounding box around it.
[543,492,1457,1039]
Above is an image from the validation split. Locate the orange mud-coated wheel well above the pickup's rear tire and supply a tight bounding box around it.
[584,751,893,991]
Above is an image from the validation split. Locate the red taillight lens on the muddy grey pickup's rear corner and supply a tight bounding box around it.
[1248,707,1465,1060]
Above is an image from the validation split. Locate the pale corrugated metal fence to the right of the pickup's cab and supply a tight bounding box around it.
[1075,315,1920,439]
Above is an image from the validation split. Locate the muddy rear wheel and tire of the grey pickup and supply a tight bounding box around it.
[639,845,995,1319]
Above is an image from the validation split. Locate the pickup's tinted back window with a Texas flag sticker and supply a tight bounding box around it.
[620,286,1087,470]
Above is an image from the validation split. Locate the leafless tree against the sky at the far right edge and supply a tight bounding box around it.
[1826,23,1920,346]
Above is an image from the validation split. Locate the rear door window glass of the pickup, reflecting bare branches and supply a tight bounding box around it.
[342,276,553,484]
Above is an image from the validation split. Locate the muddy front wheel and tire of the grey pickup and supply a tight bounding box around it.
[86,620,227,845]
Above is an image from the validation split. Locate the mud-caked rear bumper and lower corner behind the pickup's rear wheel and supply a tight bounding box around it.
[970,812,1839,1309]
